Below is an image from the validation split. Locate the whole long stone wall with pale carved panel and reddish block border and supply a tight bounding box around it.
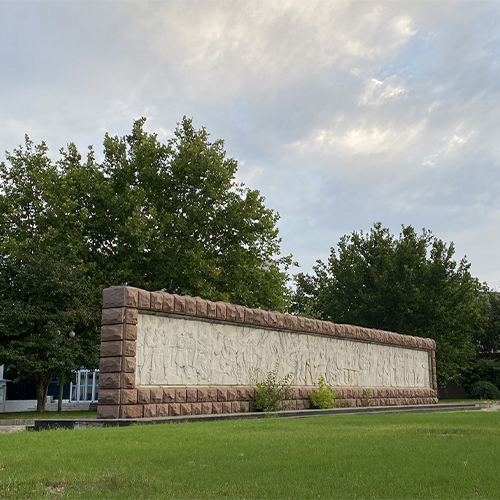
[98,287,437,418]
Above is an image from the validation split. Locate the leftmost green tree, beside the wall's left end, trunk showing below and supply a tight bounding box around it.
[0,138,99,411]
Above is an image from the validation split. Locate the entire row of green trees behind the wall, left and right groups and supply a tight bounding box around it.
[0,118,500,411]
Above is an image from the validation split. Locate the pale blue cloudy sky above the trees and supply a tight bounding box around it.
[0,0,500,289]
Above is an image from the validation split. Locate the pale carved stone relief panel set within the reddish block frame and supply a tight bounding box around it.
[136,314,431,388]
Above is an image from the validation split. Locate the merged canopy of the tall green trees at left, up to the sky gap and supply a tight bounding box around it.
[0,118,291,409]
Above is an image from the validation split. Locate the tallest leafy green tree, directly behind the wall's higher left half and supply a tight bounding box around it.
[95,118,290,310]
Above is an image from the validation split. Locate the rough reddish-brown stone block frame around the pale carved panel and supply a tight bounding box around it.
[98,286,437,418]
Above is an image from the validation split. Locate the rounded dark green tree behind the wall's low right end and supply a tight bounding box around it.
[292,223,488,385]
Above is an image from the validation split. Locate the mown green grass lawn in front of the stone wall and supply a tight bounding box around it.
[0,412,500,500]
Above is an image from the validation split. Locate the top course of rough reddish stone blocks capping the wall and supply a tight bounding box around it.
[103,286,436,351]
